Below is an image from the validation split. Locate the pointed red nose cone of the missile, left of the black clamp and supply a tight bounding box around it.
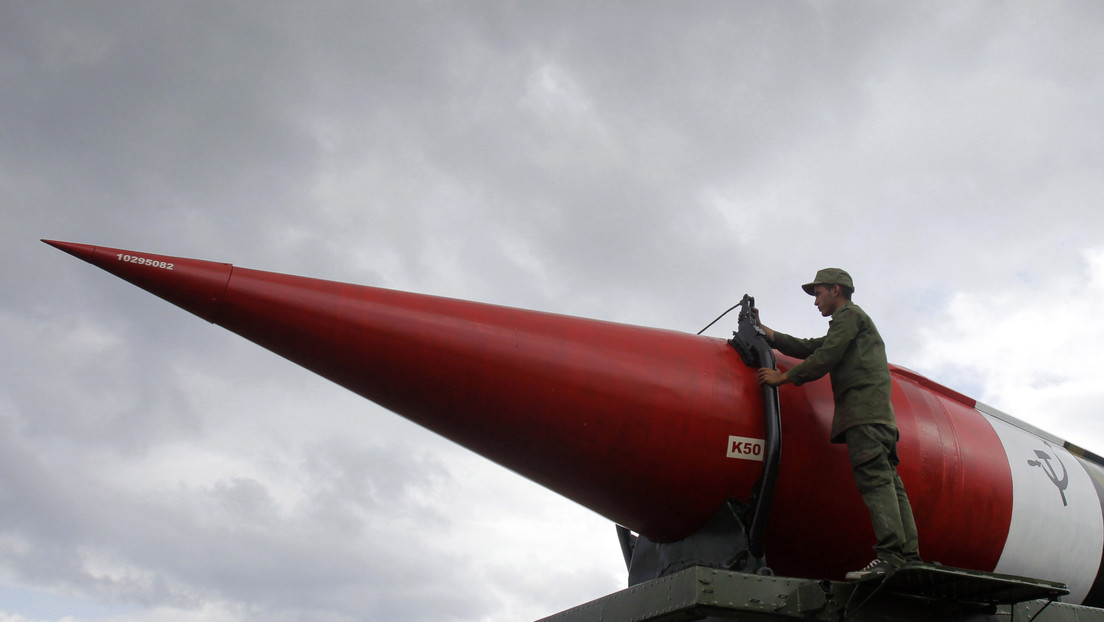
[49,242,764,541]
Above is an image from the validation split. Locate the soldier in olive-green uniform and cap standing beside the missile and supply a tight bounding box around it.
[758,267,921,580]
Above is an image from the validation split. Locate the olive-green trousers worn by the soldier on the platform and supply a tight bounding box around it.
[843,424,921,566]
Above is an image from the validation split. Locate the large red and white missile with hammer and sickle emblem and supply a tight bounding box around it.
[43,240,1104,607]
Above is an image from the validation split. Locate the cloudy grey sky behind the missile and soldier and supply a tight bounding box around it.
[0,0,1104,622]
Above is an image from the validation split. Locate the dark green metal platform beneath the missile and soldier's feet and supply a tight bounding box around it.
[539,563,1104,622]
